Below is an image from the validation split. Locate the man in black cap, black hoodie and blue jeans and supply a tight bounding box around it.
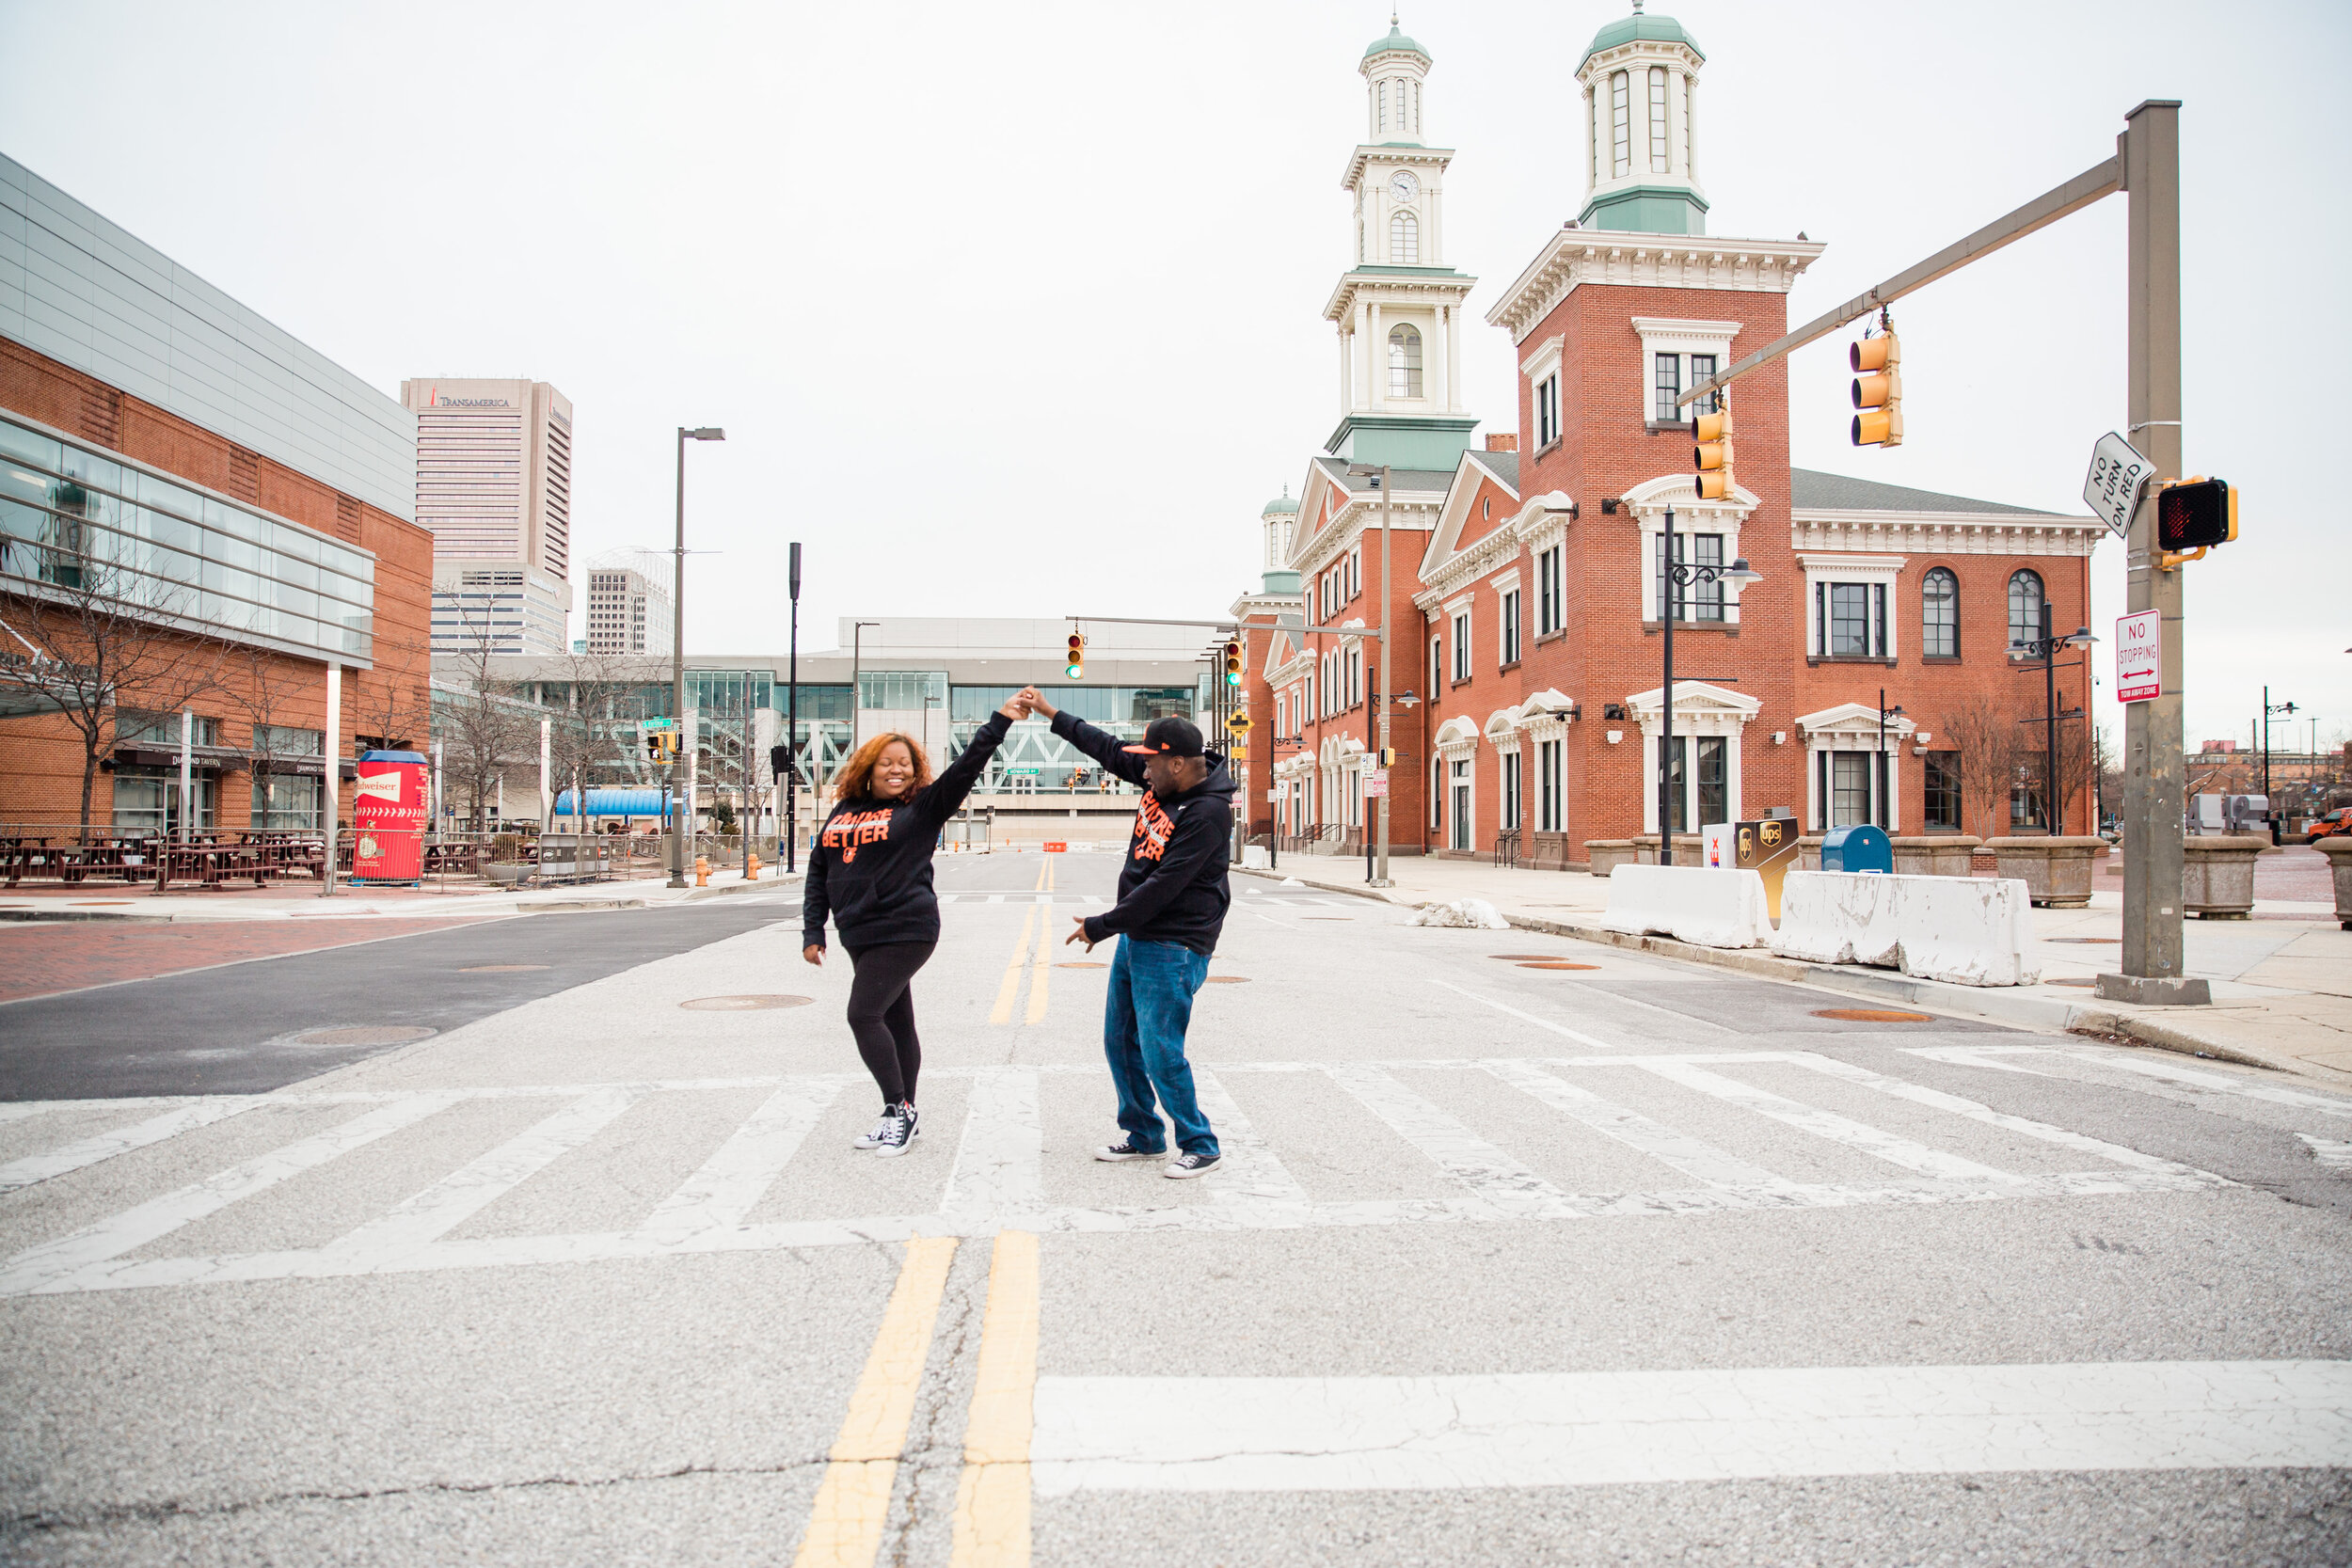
[1014,687,1235,1180]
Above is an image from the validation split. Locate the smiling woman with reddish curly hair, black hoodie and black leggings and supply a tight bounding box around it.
[800,701,1028,1159]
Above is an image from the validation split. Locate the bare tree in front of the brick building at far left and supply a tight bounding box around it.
[0,533,226,828]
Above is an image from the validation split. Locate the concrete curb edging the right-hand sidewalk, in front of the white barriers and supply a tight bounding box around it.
[1232,865,2310,1074]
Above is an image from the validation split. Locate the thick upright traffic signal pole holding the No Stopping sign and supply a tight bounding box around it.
[2098,99,2214,1004]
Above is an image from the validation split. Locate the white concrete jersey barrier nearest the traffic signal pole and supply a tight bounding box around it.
[1772,872,2042,985]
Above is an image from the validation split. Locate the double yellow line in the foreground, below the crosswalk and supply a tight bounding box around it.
[793,1229,1038,1568]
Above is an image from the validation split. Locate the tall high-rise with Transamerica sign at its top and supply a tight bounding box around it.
[400,376,572,654]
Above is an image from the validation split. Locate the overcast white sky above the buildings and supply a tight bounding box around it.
[0,0,2352,748]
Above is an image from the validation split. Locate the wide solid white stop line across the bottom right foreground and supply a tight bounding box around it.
[1030,1361,2352,1497]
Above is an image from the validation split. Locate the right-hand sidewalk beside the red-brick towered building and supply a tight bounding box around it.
[1235,856,2352,1084]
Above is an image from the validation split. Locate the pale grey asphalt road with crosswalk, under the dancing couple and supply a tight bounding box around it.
[0,856,2352,1568]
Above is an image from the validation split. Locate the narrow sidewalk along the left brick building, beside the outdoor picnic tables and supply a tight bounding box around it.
[0,865,800,931]
